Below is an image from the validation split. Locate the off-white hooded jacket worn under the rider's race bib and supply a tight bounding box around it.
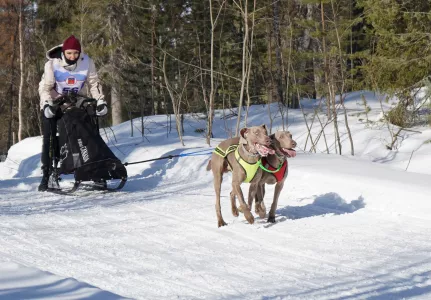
[39,45,106,109]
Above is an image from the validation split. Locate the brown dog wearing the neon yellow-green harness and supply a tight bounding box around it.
[207,125,274,227]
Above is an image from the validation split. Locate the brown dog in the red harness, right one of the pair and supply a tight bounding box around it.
[248,131,296,223]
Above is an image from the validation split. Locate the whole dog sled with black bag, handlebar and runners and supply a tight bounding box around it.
[48,94,127,194]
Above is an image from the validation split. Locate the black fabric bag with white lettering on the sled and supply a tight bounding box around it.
[58,106,127,192]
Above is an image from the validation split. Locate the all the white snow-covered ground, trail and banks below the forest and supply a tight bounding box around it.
[0,92,431,299]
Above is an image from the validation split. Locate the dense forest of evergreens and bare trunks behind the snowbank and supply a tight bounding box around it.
[0,0,431,156]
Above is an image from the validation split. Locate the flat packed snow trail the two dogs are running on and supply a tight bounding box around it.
[0,155,431,299]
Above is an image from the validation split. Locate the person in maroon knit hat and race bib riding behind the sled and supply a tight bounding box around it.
[39,35,108,191]
